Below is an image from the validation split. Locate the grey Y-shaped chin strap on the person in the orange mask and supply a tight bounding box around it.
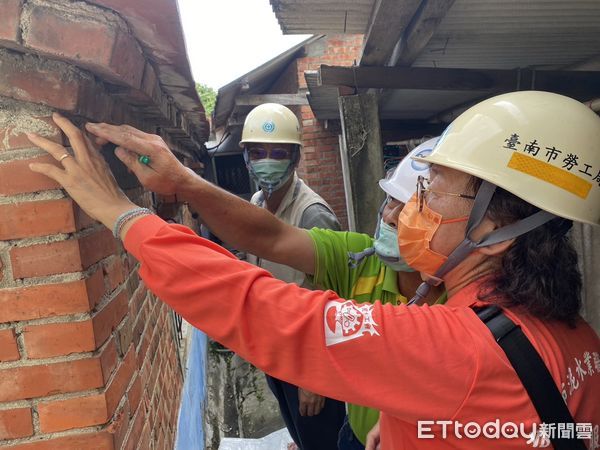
[408,181,557,305]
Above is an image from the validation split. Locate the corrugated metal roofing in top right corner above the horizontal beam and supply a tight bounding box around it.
[413,0,600,69]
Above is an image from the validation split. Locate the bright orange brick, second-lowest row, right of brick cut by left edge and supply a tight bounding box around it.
[38,394,108,433]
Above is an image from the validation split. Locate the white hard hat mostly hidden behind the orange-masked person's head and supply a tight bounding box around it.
[379,137,439,203]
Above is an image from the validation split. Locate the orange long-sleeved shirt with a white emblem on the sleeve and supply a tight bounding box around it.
[125,216,600,450]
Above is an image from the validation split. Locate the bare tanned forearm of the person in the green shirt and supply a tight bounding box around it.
[177,174,286,259]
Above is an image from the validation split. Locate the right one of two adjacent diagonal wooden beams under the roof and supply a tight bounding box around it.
[390,0,455,67]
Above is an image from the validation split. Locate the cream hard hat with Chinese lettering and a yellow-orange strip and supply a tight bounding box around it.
[416,91,600,225]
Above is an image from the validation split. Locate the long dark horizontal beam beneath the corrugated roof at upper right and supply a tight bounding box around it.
[319,65,600,100]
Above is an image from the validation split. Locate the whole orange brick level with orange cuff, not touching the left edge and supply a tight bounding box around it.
[10,239,84,278]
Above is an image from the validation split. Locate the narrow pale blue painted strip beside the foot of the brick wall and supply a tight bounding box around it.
[175,328,207,450]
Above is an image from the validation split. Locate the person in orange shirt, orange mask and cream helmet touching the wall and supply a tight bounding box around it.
[31,91,600,450]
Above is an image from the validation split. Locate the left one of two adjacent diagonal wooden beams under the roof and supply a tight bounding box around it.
[360,0,421,66]
